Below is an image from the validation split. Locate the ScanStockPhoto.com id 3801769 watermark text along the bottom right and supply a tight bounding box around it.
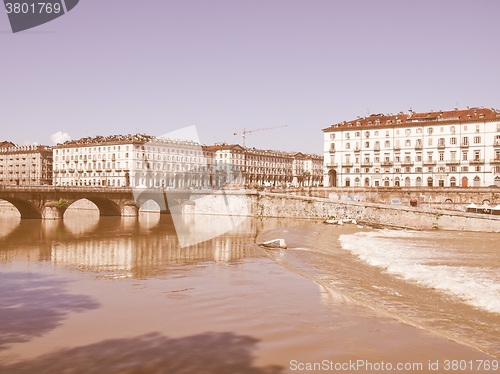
[290,359,500,373]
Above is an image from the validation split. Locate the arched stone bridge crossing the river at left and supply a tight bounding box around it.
[0,186,191,219]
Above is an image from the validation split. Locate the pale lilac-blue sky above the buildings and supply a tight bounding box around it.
[0,0,500,153]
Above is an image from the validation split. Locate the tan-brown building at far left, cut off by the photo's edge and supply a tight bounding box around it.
[0,142,52,186]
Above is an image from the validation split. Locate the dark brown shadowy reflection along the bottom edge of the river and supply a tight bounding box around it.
[0,332,284,374]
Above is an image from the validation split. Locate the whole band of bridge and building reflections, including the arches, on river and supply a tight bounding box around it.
[0,211,304,277]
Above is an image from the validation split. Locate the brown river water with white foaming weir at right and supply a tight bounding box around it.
[0,203,500,374]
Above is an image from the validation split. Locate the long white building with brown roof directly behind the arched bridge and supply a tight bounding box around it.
[53,134,209,188]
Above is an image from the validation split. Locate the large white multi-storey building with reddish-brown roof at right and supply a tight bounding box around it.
[323,108,500,187]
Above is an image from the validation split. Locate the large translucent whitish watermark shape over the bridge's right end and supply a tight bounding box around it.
[131,126,250,247]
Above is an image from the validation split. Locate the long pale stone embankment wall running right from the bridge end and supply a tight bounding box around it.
[185,191,500,232]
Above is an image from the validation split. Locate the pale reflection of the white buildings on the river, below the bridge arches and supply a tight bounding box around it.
[50,215,262,277]
